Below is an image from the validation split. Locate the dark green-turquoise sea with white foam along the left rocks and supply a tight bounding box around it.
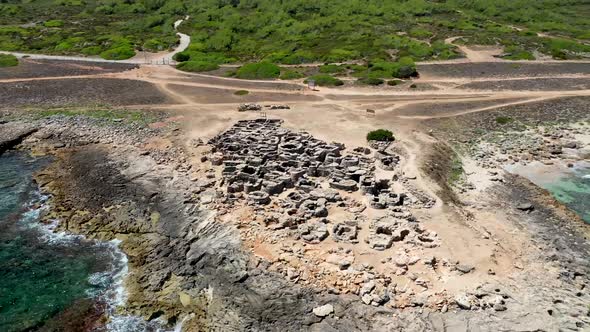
[0,152,124,332]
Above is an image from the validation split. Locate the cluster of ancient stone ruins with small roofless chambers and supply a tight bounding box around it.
[209,119,436,250]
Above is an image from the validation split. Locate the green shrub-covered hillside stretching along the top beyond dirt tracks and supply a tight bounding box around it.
[0,0,590,64]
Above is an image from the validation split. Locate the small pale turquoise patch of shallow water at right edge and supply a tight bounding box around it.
[542,164,590,223]
